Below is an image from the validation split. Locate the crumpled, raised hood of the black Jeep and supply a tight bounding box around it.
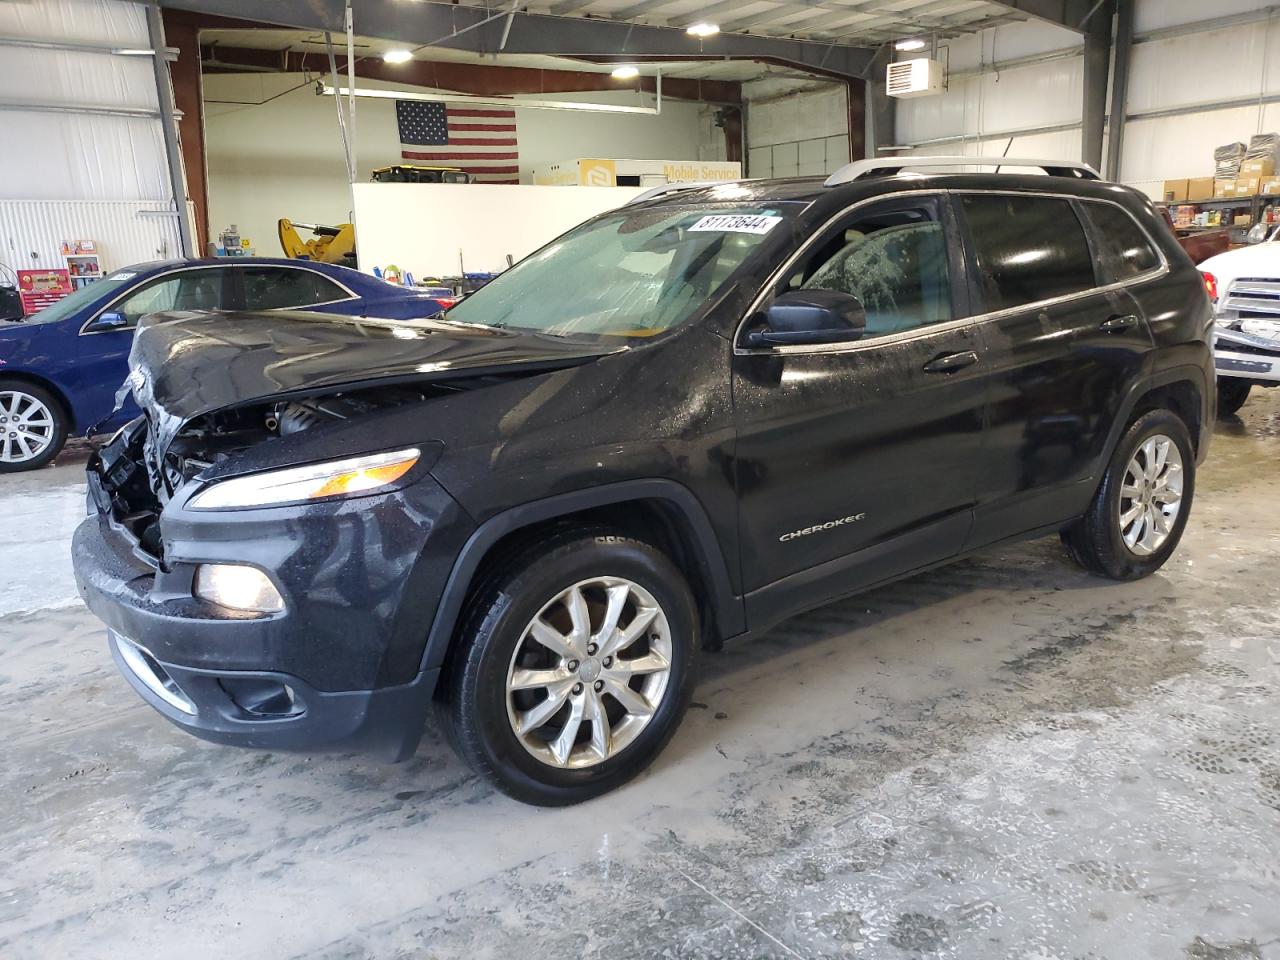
[122,311,617,451]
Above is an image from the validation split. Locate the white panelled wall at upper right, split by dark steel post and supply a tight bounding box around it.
[897,0,1280,196]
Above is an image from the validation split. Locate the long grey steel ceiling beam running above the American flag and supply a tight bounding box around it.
[161,0,876,78]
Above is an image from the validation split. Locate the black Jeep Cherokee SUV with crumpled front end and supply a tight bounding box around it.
[74,160,1215,804]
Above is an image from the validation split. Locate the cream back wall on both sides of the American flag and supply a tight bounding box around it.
[205,74,709,256]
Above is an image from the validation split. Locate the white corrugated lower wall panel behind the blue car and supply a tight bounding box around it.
[0,200,182,276]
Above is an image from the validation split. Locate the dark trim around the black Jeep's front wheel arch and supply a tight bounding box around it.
[421,477,746,671]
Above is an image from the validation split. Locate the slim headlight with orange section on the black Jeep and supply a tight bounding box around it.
[187,448,420,509]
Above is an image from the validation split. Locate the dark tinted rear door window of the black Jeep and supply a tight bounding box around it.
[960,193,1098,312]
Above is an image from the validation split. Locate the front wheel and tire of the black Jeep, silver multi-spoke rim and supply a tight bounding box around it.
[440,530,699,806]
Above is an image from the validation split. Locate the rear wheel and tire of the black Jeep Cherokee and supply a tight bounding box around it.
[1062,410,1196,580]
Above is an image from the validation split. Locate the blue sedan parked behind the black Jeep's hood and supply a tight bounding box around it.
[0,257,453,474]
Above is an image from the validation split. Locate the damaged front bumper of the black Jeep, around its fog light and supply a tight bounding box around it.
[72,463,471,762]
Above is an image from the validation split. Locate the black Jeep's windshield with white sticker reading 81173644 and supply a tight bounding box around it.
[445,204,796,337]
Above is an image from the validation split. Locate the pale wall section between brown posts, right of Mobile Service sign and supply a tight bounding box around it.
[742,78,849,177]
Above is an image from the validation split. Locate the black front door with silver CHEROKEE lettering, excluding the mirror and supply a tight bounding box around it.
[733,196,987,625]
